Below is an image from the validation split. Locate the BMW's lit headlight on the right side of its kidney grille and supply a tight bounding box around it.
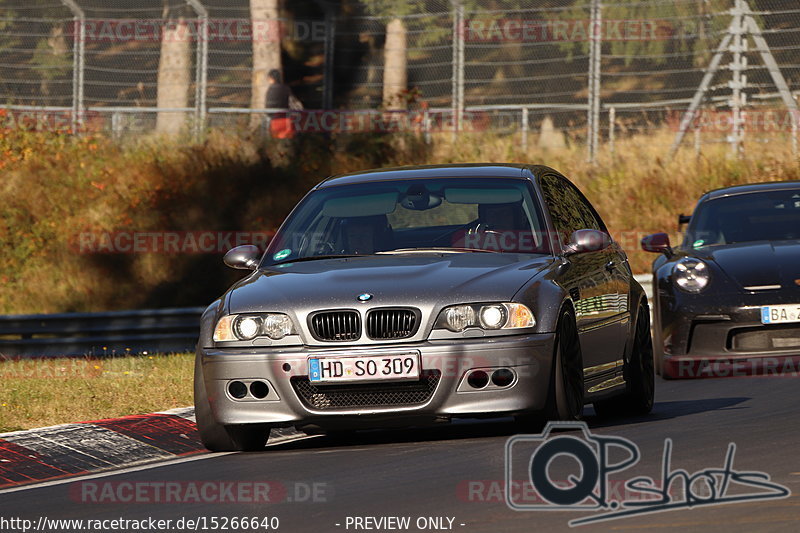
[434,303,536,333]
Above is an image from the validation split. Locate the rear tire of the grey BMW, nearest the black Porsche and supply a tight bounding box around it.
[594,305,655,416]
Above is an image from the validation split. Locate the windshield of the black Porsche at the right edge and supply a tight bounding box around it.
[684,189,800,248]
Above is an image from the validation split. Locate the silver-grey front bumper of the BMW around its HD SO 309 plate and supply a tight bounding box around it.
[197,333,555,429]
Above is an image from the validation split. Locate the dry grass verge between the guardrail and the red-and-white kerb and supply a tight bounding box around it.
[0,354,194,432]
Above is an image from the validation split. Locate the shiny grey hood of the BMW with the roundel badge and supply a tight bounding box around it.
[228,253,553,313]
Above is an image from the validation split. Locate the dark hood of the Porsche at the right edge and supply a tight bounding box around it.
[694,241,800,287]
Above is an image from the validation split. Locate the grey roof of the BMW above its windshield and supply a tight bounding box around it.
[317,163,546,188]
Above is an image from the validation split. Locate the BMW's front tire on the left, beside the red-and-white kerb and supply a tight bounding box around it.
[194,357,270,452]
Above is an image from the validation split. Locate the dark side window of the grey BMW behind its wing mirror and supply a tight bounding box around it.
[541,175,605,243]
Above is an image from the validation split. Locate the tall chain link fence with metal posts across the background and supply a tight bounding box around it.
[0,0,800,158]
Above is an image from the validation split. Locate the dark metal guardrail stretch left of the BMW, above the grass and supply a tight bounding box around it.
[0,307,205,358]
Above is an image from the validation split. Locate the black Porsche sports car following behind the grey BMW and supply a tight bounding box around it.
[642,181,800,378]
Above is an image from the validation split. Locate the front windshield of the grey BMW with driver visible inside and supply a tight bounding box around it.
[262,178,549,266]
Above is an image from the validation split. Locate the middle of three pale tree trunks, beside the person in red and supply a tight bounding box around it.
[255,0,283,126]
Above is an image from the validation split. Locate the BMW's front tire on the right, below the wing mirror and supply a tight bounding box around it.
[517,309,584,431]
